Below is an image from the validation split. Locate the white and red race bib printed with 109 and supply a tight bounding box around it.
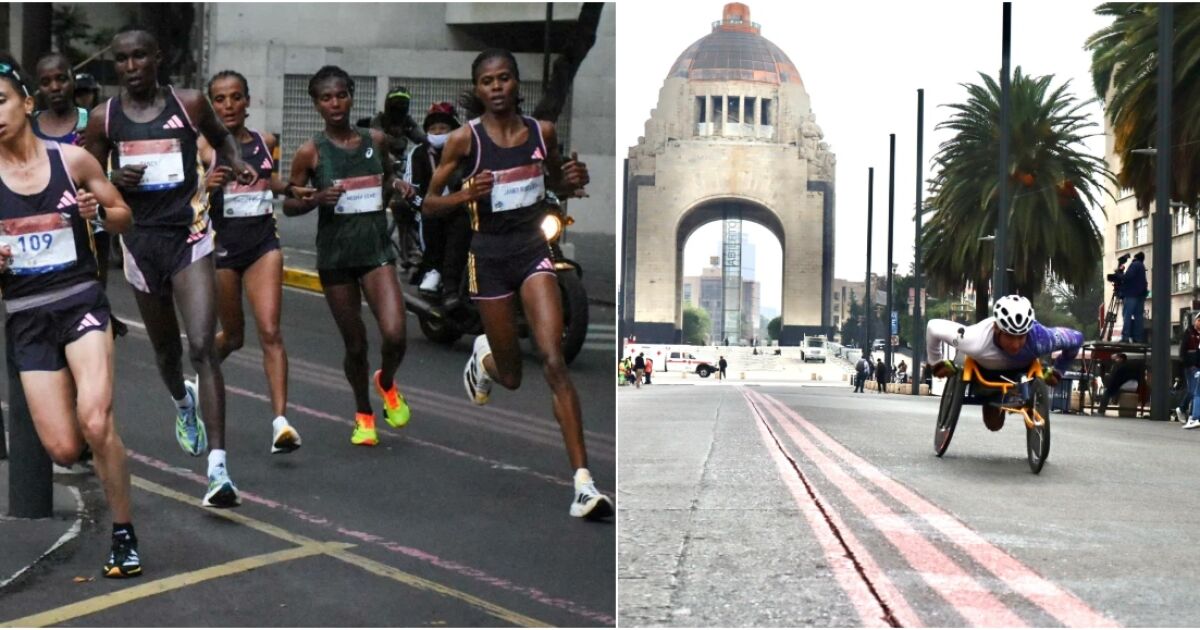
[0,214,76,276]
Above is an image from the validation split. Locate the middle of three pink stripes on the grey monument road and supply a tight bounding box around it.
[746,391,1028,628]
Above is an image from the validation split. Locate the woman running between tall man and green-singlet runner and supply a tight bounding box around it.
[199,70,302,454]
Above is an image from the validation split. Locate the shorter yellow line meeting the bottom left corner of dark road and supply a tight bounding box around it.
[0,542,353,628]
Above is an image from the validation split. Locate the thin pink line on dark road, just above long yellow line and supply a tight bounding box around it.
[126,449,617,625]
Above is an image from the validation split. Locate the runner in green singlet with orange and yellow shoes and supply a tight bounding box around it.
[283,66,413,446]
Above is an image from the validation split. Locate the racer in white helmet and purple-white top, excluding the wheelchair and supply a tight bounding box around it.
[925,295,1084,431]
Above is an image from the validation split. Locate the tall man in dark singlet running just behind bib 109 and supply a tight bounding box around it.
[86,30,258,508]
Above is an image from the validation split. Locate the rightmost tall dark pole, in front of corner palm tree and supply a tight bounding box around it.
[1150,2,1175,420]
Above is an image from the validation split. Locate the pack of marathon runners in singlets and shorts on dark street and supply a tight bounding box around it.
[0,29,613,577]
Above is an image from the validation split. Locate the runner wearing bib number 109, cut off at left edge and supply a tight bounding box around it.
[0,57,142,577]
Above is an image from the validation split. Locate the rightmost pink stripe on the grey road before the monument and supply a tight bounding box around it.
[761,395,1120,628]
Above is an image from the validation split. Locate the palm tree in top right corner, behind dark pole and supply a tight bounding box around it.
[1086,2,1200,209]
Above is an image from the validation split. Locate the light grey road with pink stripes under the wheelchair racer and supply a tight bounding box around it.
[618,384,1200,626]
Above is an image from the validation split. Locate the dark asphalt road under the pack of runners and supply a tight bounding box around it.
[0,280,616,626]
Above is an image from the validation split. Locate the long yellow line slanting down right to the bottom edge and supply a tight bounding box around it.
[131,475,550,628]
